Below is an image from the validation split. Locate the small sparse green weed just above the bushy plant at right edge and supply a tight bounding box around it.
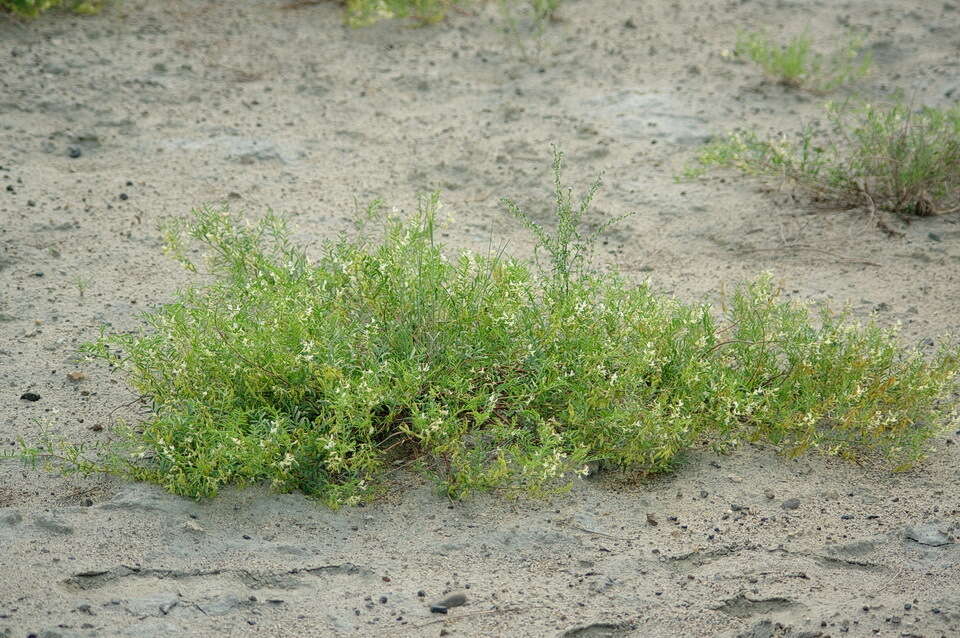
[736,31,873,93]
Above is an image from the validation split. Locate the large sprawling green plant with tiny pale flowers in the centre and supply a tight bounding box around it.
[13,155,960,506]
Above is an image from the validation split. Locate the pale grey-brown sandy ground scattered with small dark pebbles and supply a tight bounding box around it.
[0,0,960,638]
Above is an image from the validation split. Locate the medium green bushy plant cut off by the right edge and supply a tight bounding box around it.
[686,97,960,221]
